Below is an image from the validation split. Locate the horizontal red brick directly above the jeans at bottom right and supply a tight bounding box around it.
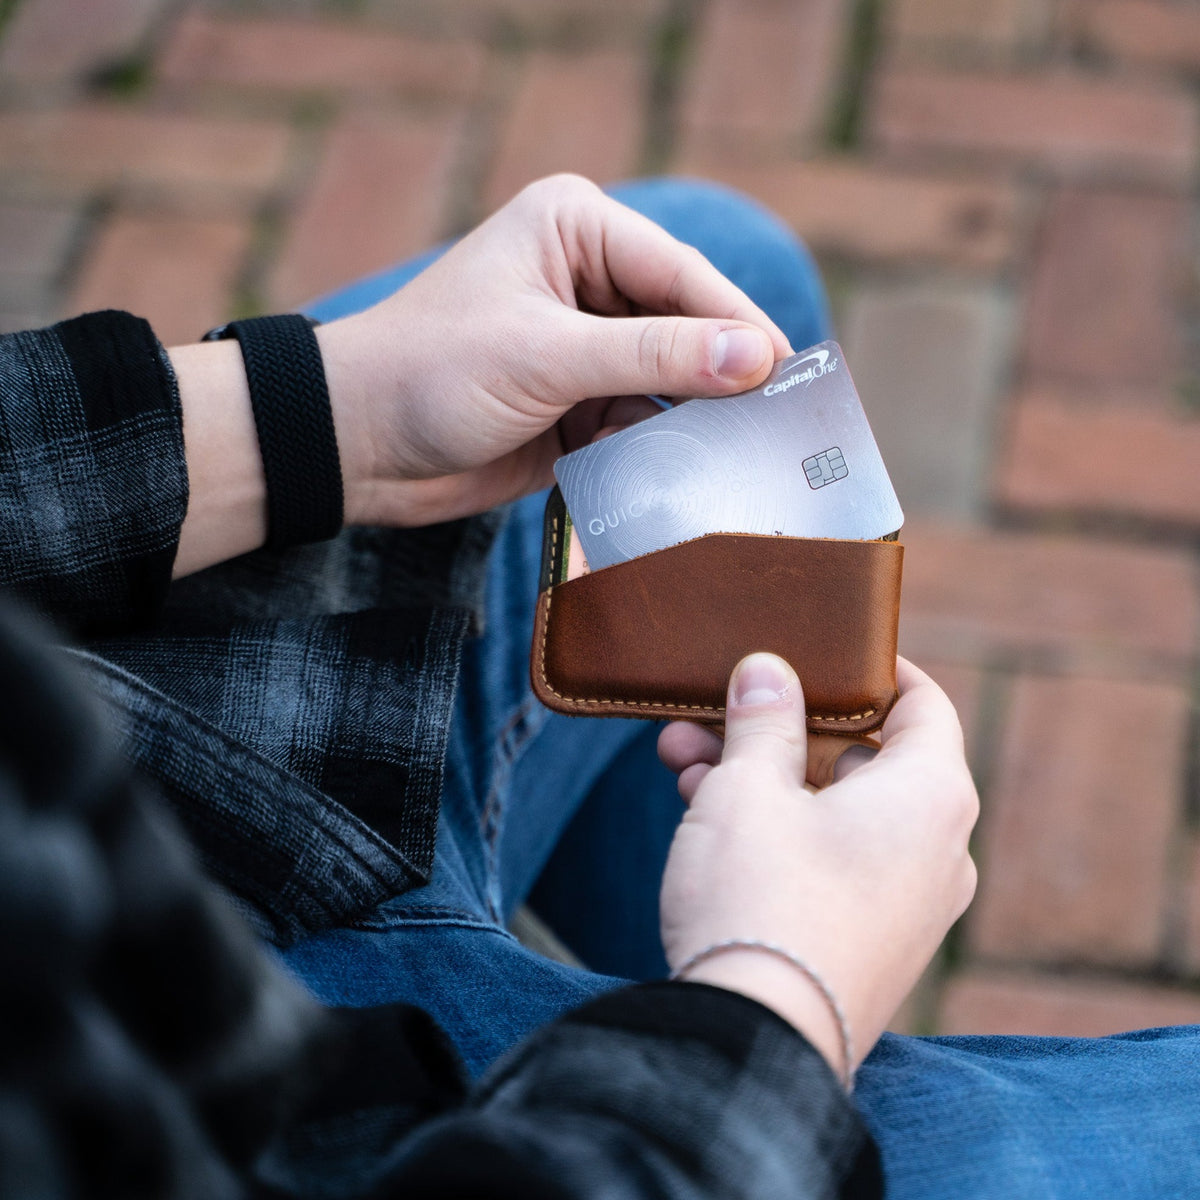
[937,970,1200,1038]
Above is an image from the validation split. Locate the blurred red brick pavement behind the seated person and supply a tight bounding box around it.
[0,0,1200,1033]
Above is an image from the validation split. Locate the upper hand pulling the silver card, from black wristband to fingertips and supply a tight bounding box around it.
[318,175,791,526]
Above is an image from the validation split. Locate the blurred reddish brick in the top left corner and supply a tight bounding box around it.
[0,0,166,84]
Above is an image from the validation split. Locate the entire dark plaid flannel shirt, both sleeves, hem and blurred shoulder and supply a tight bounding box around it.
[0,313,880,1200]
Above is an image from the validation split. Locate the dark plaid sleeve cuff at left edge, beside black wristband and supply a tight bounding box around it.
[0,312,187,635]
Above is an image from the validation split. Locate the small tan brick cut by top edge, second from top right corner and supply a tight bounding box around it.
[886,0,1042,61]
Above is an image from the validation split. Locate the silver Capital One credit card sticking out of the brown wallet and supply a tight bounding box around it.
[554,342,904,570]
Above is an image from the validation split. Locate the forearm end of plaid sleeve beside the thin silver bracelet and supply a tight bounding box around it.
[391,983,883,1200]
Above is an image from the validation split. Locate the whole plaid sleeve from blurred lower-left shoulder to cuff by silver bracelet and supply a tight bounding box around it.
[0,608,881,1200]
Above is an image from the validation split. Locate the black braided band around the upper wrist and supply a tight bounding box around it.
[203,313,343,550]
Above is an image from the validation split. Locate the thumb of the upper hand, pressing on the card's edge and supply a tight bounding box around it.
[571,316,775,396]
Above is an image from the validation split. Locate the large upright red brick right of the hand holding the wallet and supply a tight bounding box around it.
[968,676,1188,967]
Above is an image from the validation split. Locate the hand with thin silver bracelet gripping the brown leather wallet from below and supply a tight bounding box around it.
[659,654,978,1070]
